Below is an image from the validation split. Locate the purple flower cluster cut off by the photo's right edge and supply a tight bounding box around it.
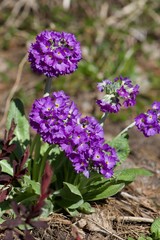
[135,102,160,137]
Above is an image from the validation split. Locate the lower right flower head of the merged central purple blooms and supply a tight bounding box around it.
[60,117,118,177]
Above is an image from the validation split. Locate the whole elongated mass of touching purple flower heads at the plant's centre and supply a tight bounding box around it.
[29,91,118,178]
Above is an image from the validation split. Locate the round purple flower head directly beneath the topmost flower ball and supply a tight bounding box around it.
[29,91,80,144]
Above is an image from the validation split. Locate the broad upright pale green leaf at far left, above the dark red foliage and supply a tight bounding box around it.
[7,99,30,146]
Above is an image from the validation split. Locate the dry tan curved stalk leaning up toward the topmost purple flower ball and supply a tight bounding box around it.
[0,53,28,128]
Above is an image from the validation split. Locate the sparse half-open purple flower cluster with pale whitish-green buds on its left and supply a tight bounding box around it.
[97,77,139,113]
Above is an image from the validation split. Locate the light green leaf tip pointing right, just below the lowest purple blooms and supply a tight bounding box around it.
[114,168,152,182]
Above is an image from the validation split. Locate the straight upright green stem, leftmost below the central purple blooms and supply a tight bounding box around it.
[32,134,41,181]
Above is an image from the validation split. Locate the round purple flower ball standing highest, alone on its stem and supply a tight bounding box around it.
[28,30,82,77]
